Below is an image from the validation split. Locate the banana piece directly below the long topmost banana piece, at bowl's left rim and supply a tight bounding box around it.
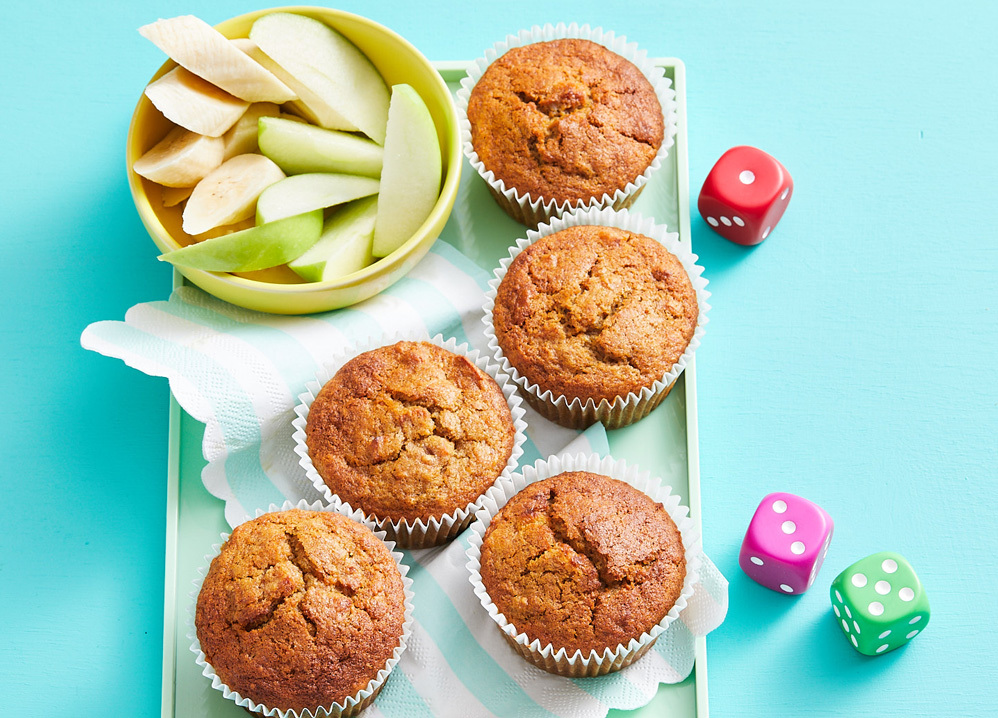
[146,67,249,137]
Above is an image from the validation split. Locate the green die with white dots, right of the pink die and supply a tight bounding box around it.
[831,551,929,656]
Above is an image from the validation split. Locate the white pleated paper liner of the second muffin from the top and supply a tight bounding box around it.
[482,209,710,429]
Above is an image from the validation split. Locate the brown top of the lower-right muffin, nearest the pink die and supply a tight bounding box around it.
[481,471,686,654]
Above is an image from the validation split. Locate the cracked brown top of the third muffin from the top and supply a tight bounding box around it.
[305,341,516,522]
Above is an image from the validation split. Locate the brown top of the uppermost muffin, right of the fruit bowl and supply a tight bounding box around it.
[468,39,664,202]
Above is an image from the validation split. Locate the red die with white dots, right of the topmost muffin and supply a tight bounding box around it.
[697,145,794,245]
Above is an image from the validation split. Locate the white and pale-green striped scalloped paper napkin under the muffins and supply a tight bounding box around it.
[81,240,727,718]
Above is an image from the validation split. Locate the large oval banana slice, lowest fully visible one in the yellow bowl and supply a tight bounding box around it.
[184,154,284,235]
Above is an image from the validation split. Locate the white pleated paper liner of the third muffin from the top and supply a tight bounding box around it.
[292,329,527,549]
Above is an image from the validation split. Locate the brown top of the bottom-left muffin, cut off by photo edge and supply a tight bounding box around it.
[195,509,405,710]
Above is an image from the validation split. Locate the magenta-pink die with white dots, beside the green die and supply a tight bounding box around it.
[738,492,833,594]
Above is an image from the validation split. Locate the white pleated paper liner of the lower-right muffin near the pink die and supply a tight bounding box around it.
[466,454,702,677]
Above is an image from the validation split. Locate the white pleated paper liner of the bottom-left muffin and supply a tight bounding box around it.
[187,499,413,718]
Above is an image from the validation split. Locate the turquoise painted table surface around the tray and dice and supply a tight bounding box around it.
[0,0,998,718]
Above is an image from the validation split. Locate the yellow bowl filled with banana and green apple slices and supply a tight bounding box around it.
[126,7,461,314]
